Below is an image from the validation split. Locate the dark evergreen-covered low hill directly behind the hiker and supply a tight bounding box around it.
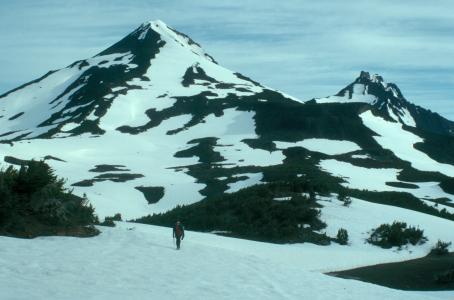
[135,182,331,244]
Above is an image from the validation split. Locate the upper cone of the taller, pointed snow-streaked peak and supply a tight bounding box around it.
[0,21,274,141]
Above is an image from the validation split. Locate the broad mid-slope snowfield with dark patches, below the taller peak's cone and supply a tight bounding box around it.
[0,109,285,219]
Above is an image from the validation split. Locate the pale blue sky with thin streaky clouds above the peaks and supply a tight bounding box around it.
[0,0,454,120]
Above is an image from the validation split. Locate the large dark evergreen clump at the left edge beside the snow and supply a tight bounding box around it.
[0,161,98,238]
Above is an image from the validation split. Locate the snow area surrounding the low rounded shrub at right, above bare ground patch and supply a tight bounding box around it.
[318,195,454,271]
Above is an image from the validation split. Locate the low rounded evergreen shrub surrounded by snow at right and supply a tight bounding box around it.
[367,221,427,248]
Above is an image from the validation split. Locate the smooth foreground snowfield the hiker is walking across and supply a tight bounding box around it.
[0,222,454,300]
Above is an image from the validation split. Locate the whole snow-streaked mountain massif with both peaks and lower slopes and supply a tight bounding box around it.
[0,21,454,223]
